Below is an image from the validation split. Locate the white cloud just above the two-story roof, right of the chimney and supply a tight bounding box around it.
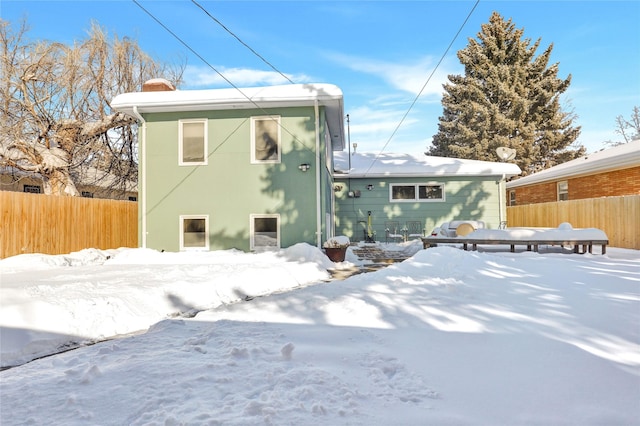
[184,65,310,89]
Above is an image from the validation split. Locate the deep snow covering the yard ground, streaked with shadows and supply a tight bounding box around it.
[0,242,640,426]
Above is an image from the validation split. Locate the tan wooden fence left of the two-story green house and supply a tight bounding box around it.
[0,191,138,259]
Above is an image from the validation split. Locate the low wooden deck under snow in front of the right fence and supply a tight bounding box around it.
[422,237,609,254]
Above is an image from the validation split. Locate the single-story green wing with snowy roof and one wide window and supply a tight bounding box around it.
[334,153,521,241]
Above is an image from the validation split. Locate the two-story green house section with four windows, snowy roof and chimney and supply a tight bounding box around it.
[111,79,344,251]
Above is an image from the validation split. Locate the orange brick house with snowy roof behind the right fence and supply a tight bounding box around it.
[507,140,640,206]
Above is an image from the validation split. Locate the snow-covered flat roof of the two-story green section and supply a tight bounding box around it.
[111,83,344,150]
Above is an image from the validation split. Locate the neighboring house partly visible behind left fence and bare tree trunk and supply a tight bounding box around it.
[0,167,138,201]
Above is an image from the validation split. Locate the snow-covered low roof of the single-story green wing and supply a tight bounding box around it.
[335,152,521,178]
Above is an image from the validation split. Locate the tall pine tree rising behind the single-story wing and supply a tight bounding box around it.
[428,12,585,175]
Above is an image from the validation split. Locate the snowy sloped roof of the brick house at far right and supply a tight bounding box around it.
[507,139,640,189]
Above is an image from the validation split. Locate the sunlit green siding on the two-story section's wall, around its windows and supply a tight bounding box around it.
[141,107,326,251]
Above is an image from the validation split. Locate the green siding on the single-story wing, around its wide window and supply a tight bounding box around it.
[336,176,504,241]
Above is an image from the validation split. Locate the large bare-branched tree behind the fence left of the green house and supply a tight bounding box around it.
[0,20,184,195]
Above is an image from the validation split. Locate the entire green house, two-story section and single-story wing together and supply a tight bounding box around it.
[111,79,520,251]
